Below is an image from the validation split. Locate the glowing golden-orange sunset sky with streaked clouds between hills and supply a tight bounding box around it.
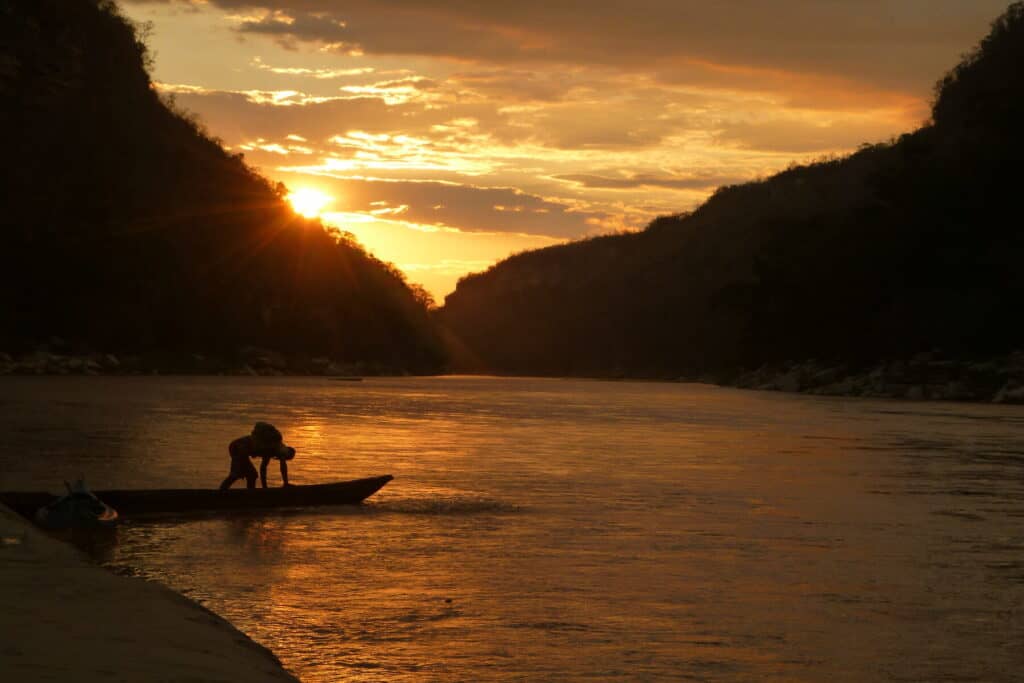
[124,0,1008,303]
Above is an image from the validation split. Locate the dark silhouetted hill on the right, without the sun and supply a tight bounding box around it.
[440,3,1024,389]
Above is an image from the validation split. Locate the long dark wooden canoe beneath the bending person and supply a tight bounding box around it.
[0,474,393,518]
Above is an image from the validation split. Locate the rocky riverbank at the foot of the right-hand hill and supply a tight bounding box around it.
[713,351,1024,403]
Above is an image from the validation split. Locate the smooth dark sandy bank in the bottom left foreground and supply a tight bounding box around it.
[0,505,296,683]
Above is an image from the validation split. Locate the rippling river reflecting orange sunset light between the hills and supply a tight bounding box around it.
[0,377,1024,683]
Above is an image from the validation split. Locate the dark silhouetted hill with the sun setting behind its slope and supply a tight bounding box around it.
[0,0,441,372]
